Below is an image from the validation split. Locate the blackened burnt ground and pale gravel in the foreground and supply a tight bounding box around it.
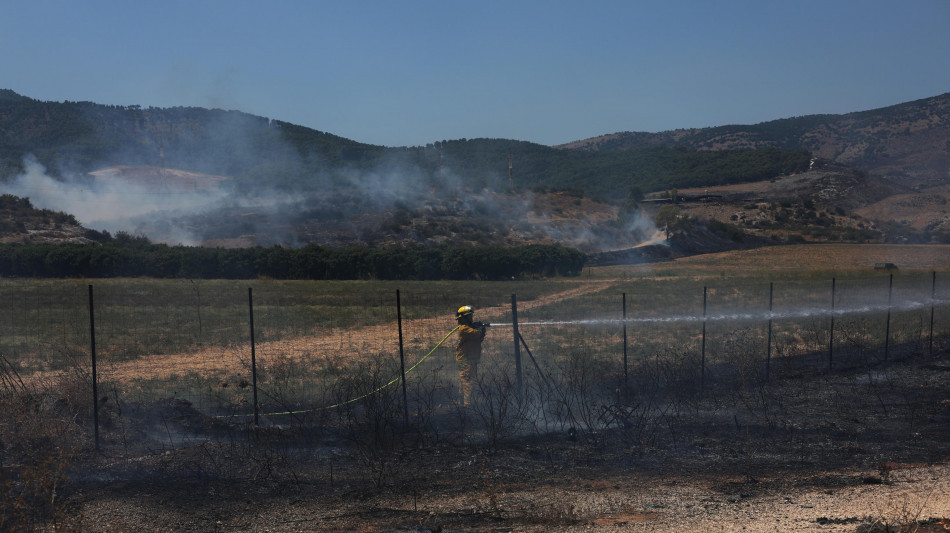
[16,354,950,532]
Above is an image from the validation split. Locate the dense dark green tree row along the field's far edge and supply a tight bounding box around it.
[0,239,586,280]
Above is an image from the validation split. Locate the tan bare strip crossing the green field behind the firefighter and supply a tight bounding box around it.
[78,244,950,383]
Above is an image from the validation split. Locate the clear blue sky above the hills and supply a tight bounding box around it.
[0,0,950,146]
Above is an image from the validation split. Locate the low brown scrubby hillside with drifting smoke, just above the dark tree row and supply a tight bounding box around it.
[9,161,950,263]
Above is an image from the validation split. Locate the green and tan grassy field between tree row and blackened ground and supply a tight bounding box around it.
[0,255,950,420]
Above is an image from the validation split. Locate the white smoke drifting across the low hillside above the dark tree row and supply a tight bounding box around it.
[0,150,657,252]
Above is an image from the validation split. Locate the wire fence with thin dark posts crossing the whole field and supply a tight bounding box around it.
[0,272,950,446]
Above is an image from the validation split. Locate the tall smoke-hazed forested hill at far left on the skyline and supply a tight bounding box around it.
[0,90,387,191]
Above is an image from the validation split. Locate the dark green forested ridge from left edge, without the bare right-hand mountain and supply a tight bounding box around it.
[0,90,809,198]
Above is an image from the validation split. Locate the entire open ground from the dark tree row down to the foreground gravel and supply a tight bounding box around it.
[0,245,950,531]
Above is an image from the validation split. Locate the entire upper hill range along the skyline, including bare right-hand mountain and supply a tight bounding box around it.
[0,89,950,197]
